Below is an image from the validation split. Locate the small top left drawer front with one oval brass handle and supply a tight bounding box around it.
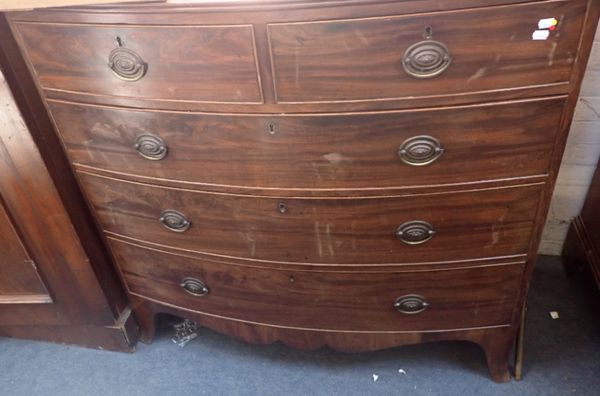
[15,22,262,103]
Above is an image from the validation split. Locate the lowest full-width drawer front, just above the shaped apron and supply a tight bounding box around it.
[110,239,523,331]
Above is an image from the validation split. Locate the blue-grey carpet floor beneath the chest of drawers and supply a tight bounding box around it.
[0,257,600,396]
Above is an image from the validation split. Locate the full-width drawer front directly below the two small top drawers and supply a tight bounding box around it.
[49,99,564,190]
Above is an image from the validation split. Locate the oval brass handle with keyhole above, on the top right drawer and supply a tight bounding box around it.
[402,27,452,78]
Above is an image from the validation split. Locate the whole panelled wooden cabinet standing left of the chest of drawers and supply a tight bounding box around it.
[0,16,137,350]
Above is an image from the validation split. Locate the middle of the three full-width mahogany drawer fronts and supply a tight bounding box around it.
[79,172,541,264]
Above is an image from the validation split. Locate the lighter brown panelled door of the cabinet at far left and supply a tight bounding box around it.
[0,68,109,327]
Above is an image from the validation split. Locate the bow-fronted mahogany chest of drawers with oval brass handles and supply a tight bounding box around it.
[9,0,600,381]
